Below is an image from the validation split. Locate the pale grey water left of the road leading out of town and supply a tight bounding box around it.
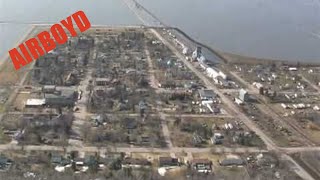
[0,0,141,57]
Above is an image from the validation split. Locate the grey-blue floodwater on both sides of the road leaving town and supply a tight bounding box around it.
[0,0,320,62]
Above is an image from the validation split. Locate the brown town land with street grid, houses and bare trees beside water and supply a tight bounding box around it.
[0,0,320,180]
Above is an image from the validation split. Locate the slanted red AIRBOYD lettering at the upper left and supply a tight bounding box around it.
[9,11,91,70]
